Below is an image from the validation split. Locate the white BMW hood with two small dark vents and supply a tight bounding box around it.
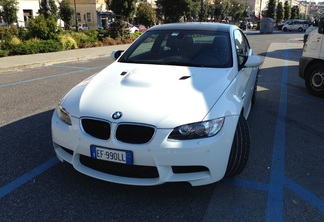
[64,62,233,128]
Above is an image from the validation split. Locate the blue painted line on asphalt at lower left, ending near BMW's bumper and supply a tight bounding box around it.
[0,157,60,199]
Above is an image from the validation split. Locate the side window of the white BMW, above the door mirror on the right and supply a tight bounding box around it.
[234,30,250,66]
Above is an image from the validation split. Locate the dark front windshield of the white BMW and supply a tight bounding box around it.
[118,30,233,68]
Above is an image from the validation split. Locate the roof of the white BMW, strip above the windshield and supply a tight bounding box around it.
[149,22,238,32]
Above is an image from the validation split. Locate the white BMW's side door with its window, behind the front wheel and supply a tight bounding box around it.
[234,30,257,114]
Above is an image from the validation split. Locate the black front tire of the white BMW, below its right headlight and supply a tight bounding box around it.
[225,115,250,177]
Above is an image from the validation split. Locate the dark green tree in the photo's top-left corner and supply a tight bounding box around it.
[0,0,18,26]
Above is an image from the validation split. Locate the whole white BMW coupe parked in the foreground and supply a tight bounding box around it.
[52,23,262,186]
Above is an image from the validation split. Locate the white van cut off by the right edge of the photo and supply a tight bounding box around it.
[299,14,324,97]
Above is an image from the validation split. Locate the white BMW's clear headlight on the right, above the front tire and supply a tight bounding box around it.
[169,117,225,140]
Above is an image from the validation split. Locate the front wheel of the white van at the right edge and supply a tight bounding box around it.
[305,63,324,97]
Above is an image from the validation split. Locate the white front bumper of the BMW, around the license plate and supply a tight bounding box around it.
[52,112,238,186]
